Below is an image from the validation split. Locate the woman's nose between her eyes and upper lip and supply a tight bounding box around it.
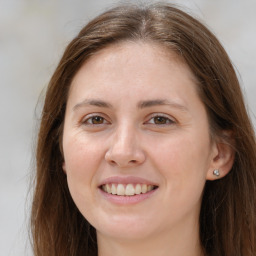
[105,125,146,168]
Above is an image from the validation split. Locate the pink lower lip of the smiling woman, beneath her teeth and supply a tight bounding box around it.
[99,188,158,205]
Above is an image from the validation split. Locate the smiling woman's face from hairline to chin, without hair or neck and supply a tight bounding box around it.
[63,42,217,242]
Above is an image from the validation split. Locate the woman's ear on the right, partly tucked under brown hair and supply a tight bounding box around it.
[206,131,235,180]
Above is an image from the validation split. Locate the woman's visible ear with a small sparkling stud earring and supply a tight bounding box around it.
[206,137,235,180]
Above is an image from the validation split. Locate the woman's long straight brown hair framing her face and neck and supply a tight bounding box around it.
[31,4,256,256]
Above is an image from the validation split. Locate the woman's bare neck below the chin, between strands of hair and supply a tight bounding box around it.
[97,221,204,256]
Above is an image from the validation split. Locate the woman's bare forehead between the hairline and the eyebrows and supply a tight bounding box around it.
[67,42,205,129]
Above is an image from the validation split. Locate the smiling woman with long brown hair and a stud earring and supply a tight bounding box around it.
[31,4,256,256]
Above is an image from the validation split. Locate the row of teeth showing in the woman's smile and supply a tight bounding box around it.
[102,184,154,196]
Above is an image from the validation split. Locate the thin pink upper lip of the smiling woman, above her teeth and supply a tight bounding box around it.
[99,176,158,187]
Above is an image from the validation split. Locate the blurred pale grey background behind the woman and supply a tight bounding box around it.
[0,0,256,256]
